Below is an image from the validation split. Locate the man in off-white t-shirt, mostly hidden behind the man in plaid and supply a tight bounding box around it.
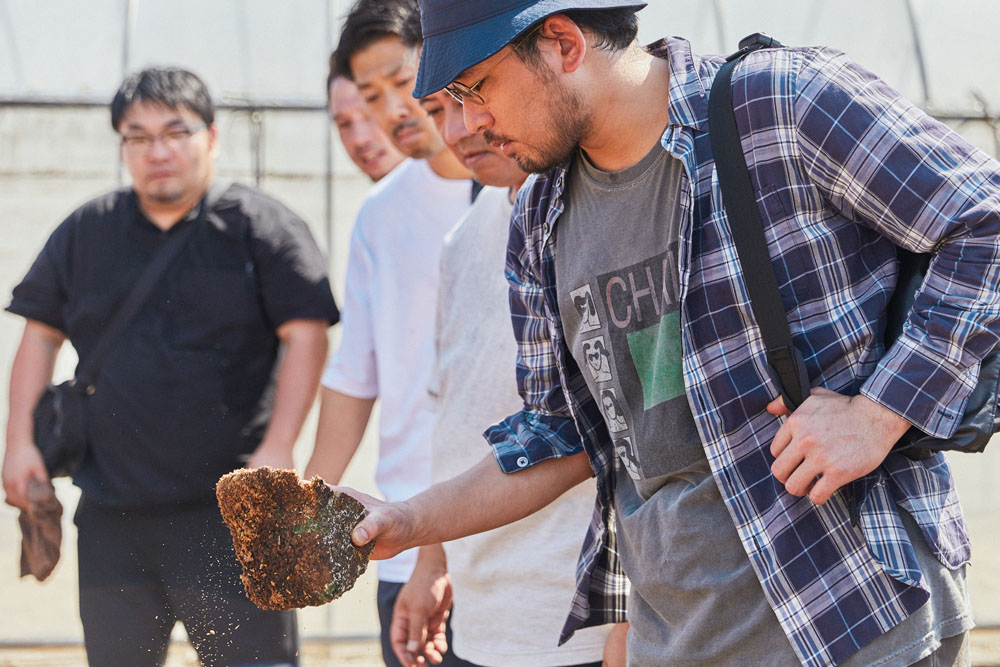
[390,22,625,667]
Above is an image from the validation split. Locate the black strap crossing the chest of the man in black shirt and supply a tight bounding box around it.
[76,185,227,394]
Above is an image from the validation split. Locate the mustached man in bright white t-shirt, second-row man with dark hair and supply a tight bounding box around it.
[305,0,472,665]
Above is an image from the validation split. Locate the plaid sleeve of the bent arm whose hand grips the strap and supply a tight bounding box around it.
[795,50,1000,437]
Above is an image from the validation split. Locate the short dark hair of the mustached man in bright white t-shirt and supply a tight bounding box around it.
[330,0,420,80]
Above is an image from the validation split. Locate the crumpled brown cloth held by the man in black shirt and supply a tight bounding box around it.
[17,477,62,581]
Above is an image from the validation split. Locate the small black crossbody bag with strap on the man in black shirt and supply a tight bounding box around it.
[33,186,225,477]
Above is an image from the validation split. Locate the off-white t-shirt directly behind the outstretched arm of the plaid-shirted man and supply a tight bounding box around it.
[431,188,610,667]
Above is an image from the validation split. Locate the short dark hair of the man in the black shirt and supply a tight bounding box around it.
[111,67,215,132]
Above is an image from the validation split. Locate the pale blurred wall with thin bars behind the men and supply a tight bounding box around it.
[0,0,1000,644]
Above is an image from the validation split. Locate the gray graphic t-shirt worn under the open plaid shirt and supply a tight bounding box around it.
[554,146,971,667]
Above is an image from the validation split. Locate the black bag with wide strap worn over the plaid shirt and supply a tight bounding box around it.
[709,33,1000,459]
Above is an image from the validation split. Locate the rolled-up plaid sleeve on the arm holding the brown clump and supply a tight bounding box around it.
[483,186,583,473]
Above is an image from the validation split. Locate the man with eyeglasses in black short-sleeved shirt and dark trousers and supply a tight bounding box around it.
[3,68,339,665]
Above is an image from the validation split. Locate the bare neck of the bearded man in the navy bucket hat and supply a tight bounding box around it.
[580,44,670,171]
